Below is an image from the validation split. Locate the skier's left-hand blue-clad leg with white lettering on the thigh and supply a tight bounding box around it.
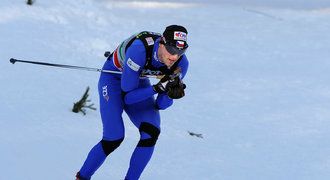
[79,75,125,179]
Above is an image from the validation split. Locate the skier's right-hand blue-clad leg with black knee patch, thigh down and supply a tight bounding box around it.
[125,81,160,180]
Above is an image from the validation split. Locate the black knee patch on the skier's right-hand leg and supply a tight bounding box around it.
[138,122,160,147]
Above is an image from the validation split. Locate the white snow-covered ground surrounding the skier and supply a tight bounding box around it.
[0,0,330,180]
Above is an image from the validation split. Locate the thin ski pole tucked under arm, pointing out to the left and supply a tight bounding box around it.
[9,58,157,78]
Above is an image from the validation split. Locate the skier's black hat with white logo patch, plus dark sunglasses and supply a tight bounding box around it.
[161,25,188,56]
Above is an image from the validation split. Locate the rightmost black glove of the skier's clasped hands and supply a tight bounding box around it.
[165,77,186,99]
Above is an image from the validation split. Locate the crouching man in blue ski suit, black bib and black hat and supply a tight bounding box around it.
[76,25,188,180]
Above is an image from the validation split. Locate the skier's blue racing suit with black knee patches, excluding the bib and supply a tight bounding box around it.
[79,34,188,180]
